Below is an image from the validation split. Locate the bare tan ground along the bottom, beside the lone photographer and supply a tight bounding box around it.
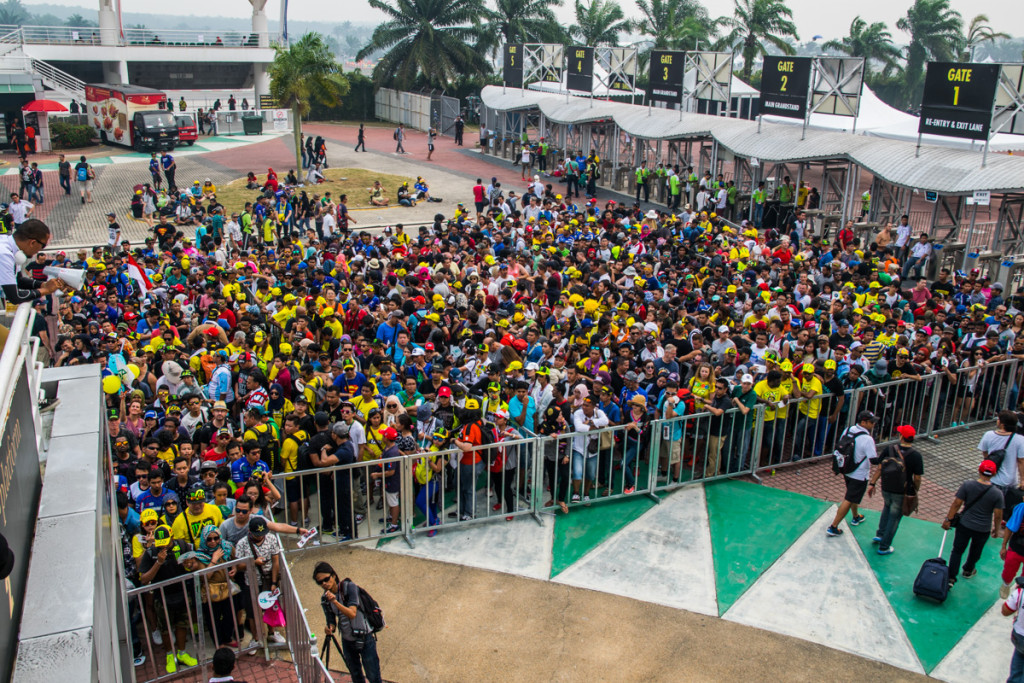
[292,541,929,683]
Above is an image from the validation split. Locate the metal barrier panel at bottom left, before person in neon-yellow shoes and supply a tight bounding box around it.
[127,555,266,683]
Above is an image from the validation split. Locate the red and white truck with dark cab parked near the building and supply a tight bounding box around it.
[85,83,179,152]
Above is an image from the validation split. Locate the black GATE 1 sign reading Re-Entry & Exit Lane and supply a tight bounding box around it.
[918,61,999,140]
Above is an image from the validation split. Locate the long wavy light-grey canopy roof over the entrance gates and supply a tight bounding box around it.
[481,86,1024,195]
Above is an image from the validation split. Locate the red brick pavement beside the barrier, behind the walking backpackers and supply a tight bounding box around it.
[751,458,956,522]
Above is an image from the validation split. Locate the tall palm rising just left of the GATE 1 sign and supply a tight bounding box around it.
[896,0,964,101]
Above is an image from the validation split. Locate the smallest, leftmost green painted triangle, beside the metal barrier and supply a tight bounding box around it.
[551,496,657,579]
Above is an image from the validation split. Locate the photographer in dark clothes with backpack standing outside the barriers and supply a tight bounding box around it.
[313,562,381,683]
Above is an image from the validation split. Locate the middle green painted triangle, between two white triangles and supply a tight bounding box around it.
[705,481,830,615]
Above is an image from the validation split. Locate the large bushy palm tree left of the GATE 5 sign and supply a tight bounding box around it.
[355,0,489,88]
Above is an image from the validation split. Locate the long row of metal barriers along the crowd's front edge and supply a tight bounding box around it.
[273,359,1024,552]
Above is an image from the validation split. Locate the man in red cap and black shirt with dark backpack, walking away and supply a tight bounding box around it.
[867,425,925,555]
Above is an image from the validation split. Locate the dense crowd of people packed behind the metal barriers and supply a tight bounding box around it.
[9,126,1024,671]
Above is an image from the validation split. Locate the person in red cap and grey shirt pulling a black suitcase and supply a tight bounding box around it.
[942,460,1002,588]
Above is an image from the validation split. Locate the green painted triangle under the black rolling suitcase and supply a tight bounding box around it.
[847,508,1002,673]
